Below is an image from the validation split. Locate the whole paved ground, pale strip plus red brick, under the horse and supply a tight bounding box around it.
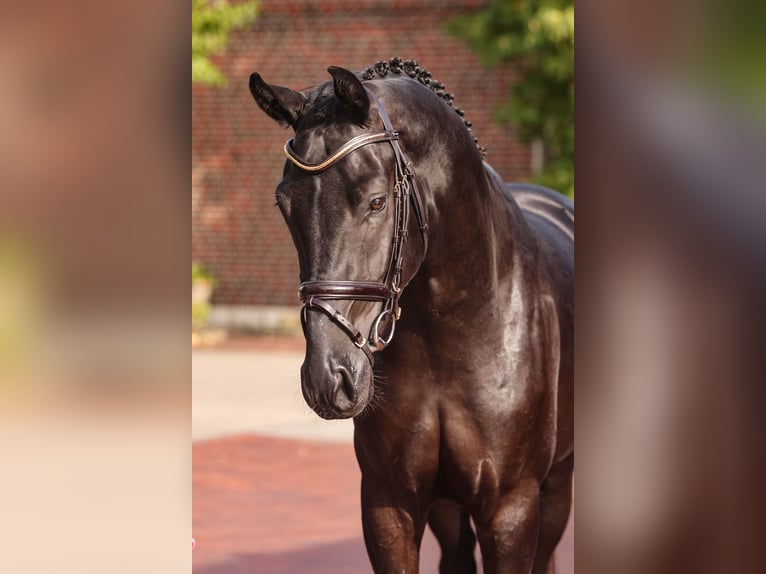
[192,340,574,574]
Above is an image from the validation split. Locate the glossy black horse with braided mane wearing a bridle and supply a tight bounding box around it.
[250,58,574,573]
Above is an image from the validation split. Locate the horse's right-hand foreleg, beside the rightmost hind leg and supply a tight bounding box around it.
[474,480,540,574]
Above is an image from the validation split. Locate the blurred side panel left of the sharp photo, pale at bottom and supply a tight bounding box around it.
[0,0,191,573]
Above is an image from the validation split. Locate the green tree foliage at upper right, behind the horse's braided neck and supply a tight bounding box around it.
[447,0,574,197]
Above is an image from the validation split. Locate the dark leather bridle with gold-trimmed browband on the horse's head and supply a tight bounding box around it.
[284,88,428,363]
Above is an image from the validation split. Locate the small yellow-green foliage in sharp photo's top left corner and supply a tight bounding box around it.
[192,0,258,84]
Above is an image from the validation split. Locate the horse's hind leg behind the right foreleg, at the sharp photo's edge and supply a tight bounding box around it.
[532,454,574,574]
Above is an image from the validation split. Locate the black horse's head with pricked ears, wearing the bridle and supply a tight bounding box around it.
[250,67,426,419]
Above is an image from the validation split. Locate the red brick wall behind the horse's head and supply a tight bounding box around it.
[192,0,530,305]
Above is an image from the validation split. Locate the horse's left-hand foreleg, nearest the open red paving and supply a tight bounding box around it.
[362,478,425,574]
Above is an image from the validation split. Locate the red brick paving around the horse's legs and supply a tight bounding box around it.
[192,436,574,574]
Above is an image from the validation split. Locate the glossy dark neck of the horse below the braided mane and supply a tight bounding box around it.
[396,85,537,315]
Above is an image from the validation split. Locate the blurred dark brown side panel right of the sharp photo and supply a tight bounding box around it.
[575,0,766,574]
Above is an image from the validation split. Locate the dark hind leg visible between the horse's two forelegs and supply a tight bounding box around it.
[428,499,476,574]
